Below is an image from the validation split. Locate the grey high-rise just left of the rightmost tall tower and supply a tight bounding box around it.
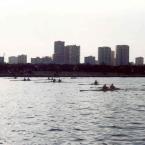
[98,47,111,65]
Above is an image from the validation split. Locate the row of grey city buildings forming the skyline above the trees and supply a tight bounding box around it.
[4,40,144,66]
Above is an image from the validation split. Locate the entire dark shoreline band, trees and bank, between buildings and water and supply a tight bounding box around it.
[0,64,145,77]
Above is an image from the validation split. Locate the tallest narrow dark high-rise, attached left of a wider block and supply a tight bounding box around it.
[53,41,65,64]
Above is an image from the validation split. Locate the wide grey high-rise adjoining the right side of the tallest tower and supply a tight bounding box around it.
[64,45,80,64]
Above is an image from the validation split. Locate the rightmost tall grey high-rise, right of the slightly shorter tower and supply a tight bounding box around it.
[116,45,129,66]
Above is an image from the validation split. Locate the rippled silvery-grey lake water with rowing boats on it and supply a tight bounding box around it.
[0,78,145,145]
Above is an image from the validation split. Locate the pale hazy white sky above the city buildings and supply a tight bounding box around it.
[0,0,145,61]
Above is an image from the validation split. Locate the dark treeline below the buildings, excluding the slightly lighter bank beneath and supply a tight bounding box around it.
[0,64,145,75]
